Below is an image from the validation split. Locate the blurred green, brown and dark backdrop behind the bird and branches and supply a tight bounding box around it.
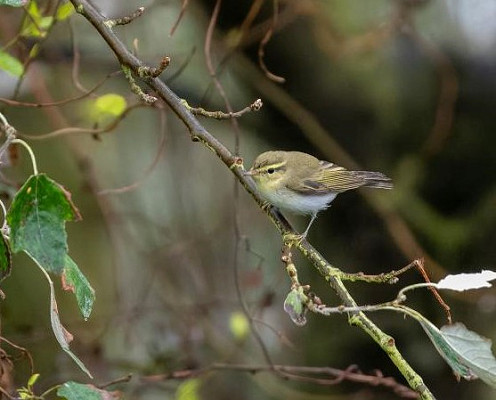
[0,0,496,400]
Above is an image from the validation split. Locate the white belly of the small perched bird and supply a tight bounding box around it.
[259,188,337,214]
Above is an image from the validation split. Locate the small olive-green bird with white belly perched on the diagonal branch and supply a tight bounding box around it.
[246,151,393,237]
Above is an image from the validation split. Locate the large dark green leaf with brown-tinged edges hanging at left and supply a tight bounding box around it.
[7,174,81,274]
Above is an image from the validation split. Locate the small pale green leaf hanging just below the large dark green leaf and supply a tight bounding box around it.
[62,256,95,319]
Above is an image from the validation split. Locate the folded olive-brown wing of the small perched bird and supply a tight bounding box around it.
[296,161,367,195]
